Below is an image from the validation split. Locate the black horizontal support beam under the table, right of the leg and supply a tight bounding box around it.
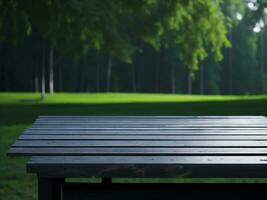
[63,183,267,200]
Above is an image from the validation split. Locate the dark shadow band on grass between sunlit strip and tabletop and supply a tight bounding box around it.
[0,100,267,125]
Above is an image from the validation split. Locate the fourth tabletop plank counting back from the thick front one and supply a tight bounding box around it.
[19,134,267,141]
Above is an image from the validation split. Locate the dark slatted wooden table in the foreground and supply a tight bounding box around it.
[8,116,267,200]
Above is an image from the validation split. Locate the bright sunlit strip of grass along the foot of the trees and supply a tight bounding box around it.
[0,93,267,105]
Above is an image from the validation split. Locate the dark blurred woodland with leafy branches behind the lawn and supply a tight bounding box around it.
[0,0,267,95]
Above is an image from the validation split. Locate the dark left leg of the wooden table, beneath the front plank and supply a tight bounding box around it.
[38,177,65,200]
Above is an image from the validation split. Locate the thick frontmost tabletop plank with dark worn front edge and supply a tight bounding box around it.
[27,156,267,178]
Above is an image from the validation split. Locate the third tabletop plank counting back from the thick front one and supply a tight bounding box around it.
[12,140,267,148]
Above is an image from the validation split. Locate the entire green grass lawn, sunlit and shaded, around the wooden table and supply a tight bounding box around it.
[0,93,267,200]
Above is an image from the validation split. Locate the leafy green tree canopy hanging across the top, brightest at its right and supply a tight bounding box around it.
[0,0,230,72]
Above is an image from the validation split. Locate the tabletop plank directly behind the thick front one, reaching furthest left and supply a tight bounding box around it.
[8,147,267,156]
